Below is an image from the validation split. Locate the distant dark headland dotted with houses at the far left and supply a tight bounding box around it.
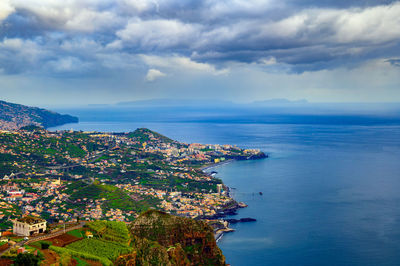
[0,101,79,130]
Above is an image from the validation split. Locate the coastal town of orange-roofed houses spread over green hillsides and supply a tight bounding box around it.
[0,126,266,231]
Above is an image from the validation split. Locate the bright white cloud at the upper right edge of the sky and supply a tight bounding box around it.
[254,2,400,44]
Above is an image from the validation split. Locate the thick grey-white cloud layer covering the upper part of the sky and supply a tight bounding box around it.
[0,0,400,74]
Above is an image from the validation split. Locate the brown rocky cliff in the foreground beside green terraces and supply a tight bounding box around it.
[116,210,226,265]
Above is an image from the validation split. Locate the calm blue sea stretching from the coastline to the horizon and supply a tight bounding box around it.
[49,108,400,265]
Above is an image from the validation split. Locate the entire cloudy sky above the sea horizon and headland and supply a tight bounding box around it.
[0,0,400,106]
